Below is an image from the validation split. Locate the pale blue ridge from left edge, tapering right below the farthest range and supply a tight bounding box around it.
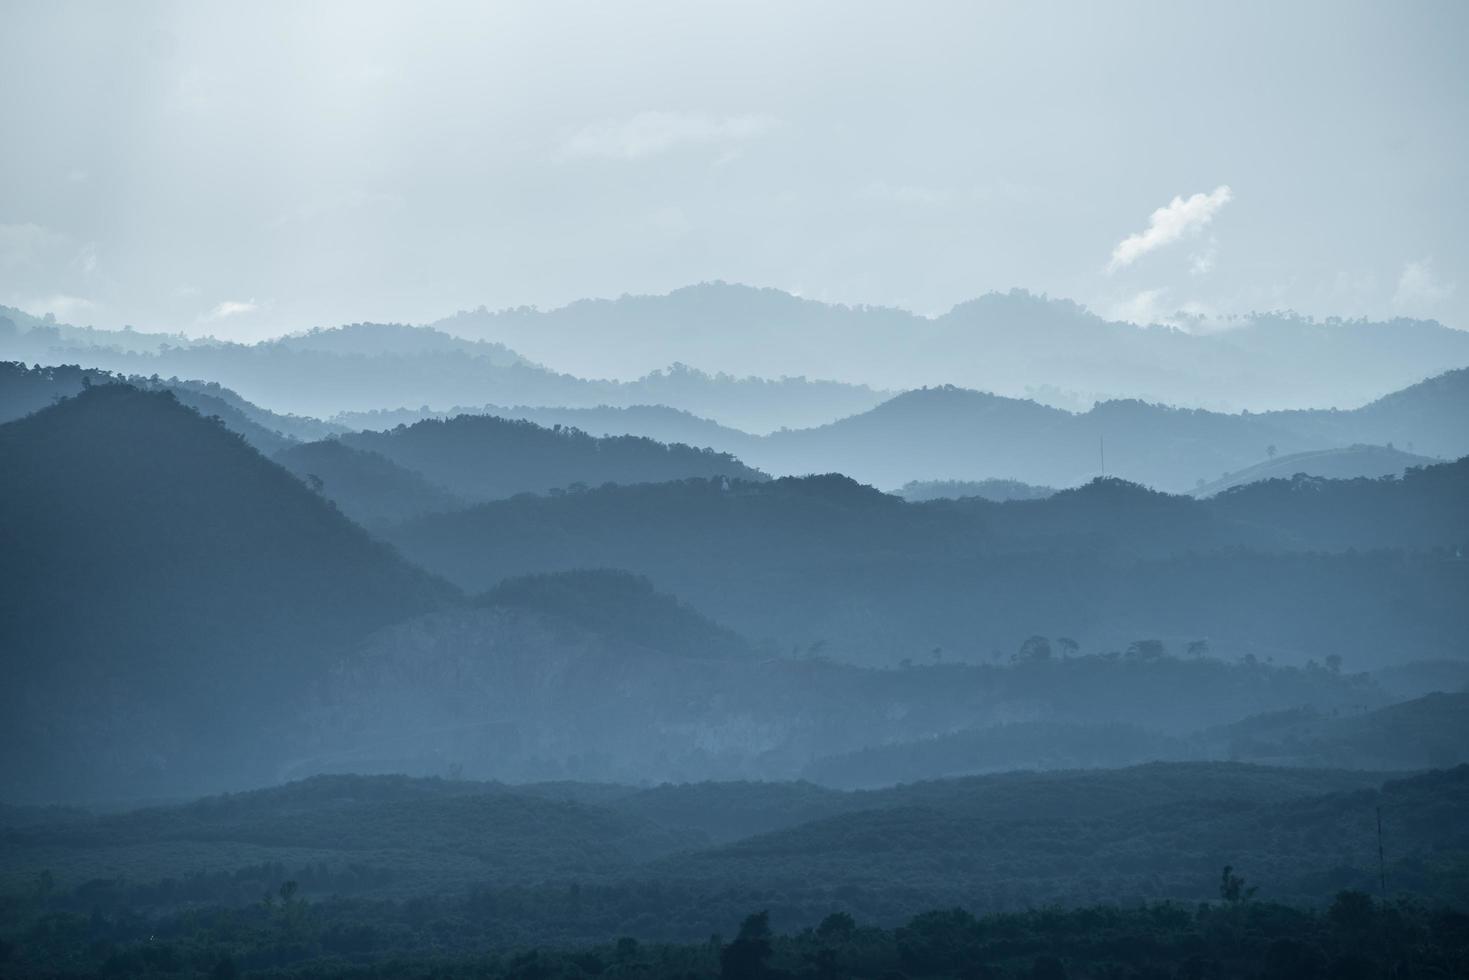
[0,307,884,432]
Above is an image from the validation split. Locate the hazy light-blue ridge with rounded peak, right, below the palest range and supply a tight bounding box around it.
[338,370,1469,492]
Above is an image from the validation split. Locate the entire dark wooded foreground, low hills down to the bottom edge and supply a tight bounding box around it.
[0,765,1469,977]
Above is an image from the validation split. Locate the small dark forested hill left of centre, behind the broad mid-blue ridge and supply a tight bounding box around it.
[341,416,764,501]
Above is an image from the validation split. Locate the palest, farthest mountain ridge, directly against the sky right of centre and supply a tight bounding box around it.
[433,282,1469,411]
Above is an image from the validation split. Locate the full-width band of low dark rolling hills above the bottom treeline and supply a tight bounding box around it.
[0,764,1451,942]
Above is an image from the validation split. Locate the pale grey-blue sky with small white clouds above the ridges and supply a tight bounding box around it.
[0,0,1469,339]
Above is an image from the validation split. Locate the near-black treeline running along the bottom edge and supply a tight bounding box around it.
[0,887,1469,980]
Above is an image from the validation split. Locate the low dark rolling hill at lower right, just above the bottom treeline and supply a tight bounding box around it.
[654,764,1469,914]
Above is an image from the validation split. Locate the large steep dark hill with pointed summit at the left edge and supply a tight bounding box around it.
[0,385,452,796]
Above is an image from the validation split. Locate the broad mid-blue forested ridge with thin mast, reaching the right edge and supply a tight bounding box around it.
[388,461,1469,664]
